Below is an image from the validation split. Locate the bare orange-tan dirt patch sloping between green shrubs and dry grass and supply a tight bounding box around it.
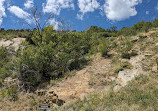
[49,54,110,101]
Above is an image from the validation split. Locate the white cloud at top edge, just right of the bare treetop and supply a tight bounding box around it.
[43,0,74,15]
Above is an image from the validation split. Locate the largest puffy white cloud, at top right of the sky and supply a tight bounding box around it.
[104,0,142,21]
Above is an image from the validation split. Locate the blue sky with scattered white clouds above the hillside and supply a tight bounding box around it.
[0,0,158,31]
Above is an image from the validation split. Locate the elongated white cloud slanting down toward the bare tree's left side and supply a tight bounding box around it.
[8,6,31,23]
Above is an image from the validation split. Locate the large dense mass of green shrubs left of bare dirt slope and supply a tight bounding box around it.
[19,26,91,87]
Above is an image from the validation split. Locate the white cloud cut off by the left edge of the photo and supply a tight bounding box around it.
[0,0,6,25]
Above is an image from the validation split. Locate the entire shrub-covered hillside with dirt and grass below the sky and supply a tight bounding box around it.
[0,20,158,111]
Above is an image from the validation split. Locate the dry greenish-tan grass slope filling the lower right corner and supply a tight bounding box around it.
[53,73,158,111]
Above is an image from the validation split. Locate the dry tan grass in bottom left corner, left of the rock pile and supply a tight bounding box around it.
[0,93,39,111]
